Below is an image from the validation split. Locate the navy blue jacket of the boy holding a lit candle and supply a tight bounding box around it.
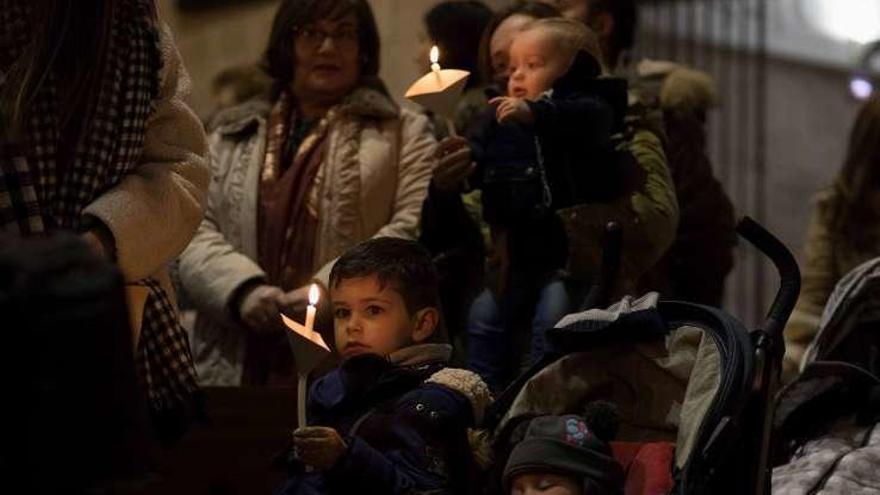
[278,355,485,495]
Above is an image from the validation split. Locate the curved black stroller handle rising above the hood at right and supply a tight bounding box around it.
[736,216,801,337]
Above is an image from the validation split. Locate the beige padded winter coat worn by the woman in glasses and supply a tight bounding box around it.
[180,88,436,385]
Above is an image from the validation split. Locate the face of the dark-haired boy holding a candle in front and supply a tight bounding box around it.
[330,275,436,358]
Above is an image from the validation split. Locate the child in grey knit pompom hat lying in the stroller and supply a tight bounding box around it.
[503,403,624,495]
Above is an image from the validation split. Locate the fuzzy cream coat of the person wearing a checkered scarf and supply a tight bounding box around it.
[83,26,210,341]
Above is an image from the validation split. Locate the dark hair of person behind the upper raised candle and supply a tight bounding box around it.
[424,0,492,87]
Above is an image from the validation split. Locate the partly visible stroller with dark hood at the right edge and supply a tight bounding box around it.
[773,259,880,495]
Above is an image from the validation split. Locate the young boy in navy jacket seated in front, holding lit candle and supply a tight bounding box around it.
[279,238,490,494]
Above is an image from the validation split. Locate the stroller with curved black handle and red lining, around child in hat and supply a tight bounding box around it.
[483,218,800,495]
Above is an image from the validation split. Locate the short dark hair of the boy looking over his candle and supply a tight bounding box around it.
[330,237,440,314]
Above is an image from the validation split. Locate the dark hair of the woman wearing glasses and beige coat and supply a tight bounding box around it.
[263,0,379,97]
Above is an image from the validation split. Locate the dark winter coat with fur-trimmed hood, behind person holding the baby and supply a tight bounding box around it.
[633,62,737,306]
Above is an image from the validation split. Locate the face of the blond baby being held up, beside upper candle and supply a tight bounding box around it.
[507,29,569,100]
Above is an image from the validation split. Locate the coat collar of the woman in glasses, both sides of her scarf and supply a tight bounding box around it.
[208,80,400,135]
